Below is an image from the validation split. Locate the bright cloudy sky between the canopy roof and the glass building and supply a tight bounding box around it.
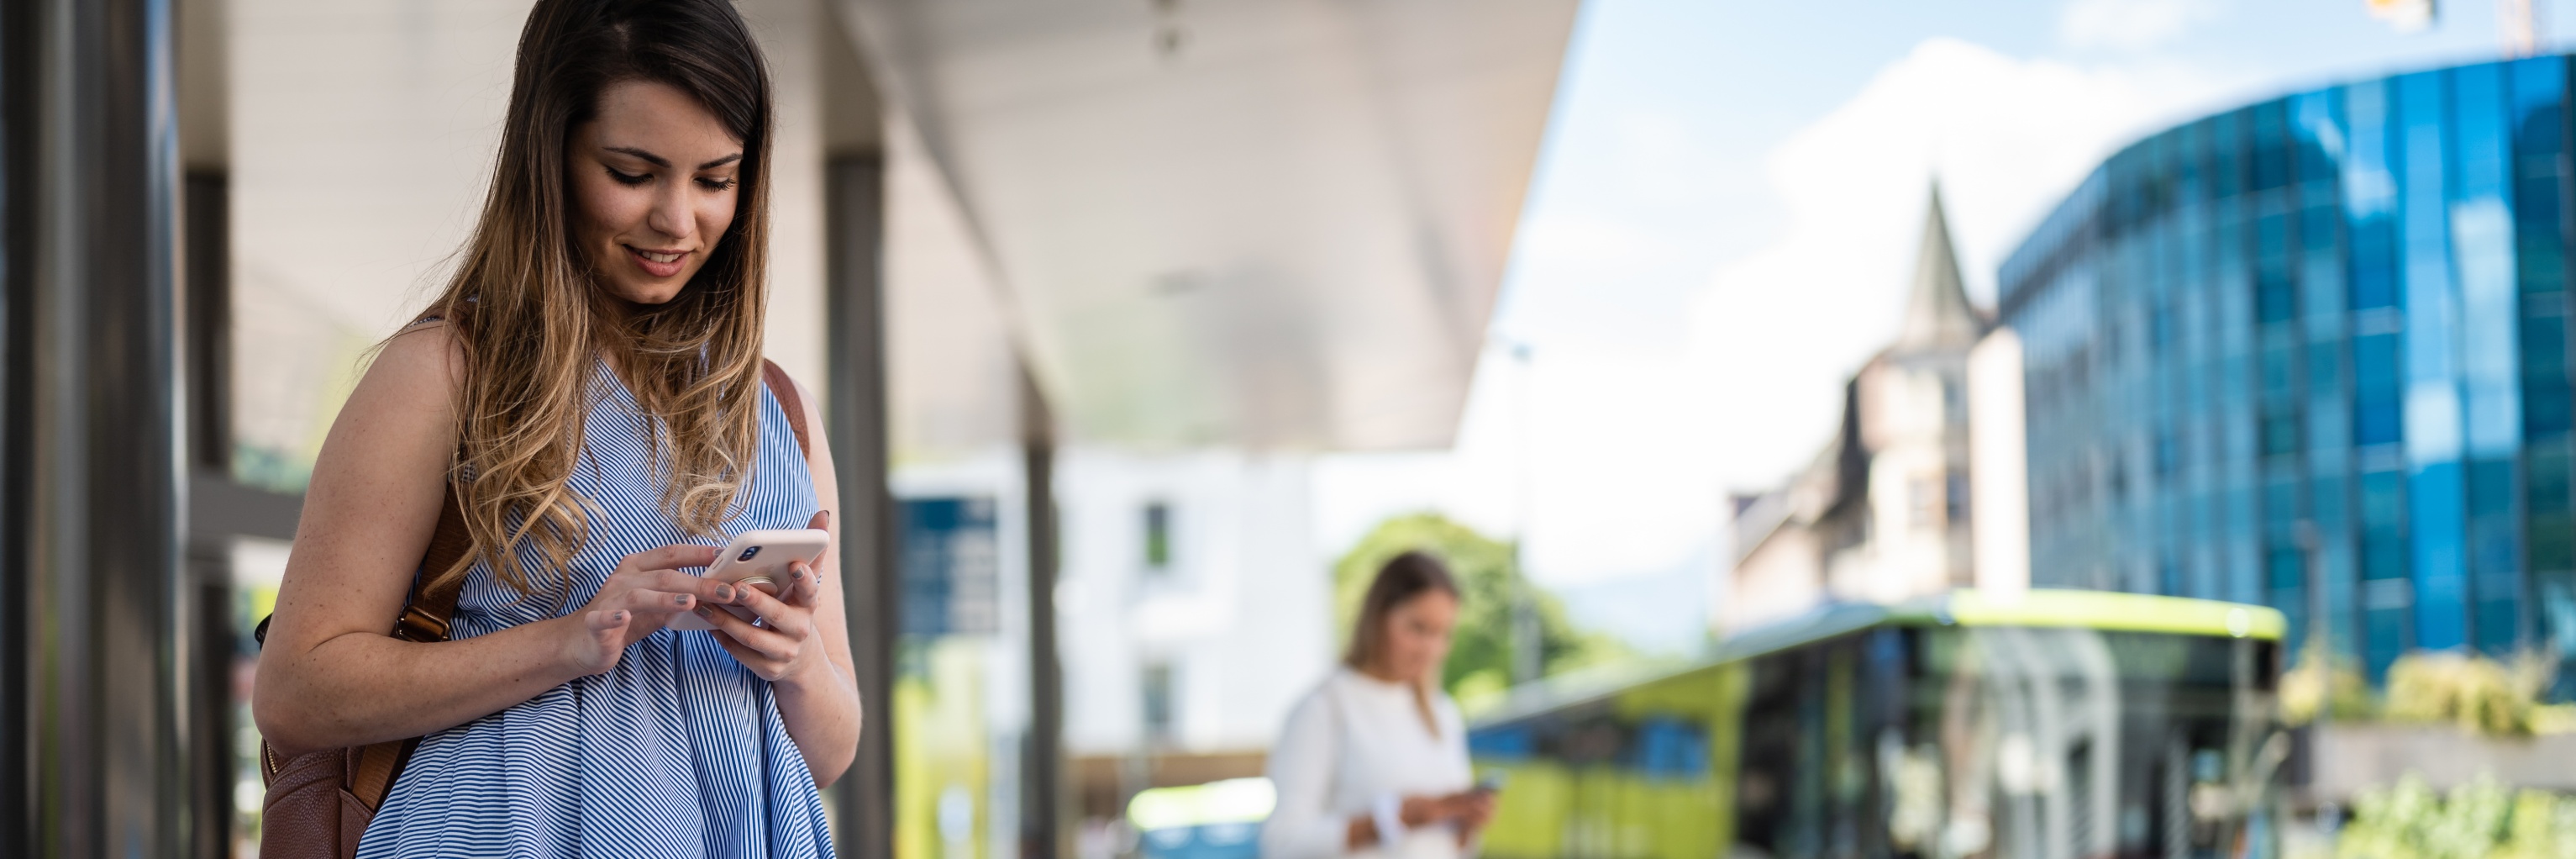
[1317,0,2576,650]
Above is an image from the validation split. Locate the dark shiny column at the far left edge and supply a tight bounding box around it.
[0,0,193,856]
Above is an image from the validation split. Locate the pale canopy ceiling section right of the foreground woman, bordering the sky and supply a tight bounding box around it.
[837,0,1576,449]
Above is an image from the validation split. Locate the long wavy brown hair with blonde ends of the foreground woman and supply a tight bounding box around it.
[428,0,773,596]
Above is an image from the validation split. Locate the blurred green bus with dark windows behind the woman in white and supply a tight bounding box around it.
[1469,591,2290,859]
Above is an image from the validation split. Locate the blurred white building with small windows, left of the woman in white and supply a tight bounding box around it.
[1056,449,1334,813]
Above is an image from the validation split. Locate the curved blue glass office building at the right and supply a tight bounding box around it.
[1999,57,2576,676]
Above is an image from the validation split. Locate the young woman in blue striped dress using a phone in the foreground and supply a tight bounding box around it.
[252,0,860,856]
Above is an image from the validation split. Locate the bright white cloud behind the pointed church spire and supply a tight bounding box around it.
[1692,39,2213,487]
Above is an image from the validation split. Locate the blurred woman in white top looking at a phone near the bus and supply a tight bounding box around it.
[1262,552,1494,859]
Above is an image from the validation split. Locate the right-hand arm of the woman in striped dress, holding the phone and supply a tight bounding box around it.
[698,384,863,787]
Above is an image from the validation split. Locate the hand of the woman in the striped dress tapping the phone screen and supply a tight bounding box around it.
[564,545,726,673]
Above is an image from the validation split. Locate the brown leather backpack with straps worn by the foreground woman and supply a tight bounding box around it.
[258,361,814,859]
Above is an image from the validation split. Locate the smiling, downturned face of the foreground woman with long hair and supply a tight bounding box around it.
[564,80,742,304]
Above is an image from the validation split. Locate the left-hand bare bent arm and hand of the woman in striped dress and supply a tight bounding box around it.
[250,325,732,756]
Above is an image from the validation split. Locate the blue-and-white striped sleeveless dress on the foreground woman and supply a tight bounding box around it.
[358,366,832,859]
